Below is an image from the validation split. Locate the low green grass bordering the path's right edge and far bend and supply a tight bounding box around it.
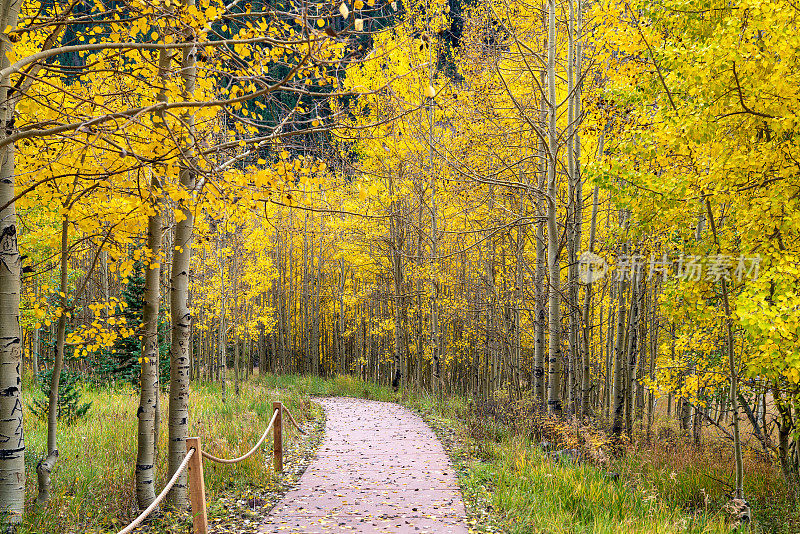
[263,375,748,534]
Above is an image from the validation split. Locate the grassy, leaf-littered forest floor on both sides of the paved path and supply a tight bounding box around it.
[20,375,800,534]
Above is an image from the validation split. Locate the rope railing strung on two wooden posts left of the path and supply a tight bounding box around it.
[117,401,306,534]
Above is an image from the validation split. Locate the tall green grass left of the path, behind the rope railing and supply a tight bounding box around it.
[20,382,310,534]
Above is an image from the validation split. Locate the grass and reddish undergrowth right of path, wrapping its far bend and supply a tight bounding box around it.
[262,375,800,534]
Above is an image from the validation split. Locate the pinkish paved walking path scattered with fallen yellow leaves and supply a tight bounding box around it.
[260,397,467,534]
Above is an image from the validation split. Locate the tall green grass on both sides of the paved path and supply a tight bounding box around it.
[21,374,788,534]
